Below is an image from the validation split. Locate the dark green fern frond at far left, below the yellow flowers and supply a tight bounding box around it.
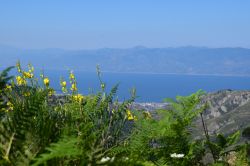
[0,89,46,165]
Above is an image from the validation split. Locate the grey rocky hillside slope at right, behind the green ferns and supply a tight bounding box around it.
[196,90,250,135]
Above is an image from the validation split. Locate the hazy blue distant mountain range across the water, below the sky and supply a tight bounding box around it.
[0,46,250,76]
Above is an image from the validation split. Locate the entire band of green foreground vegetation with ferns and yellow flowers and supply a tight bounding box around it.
[0,62,249,166]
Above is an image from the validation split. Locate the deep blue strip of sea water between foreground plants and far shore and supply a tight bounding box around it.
[45,71,250,102]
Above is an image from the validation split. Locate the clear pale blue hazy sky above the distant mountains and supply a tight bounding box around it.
[0,0,250,49]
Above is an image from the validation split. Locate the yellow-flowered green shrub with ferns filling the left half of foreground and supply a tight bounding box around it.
[0,62,138,165]
